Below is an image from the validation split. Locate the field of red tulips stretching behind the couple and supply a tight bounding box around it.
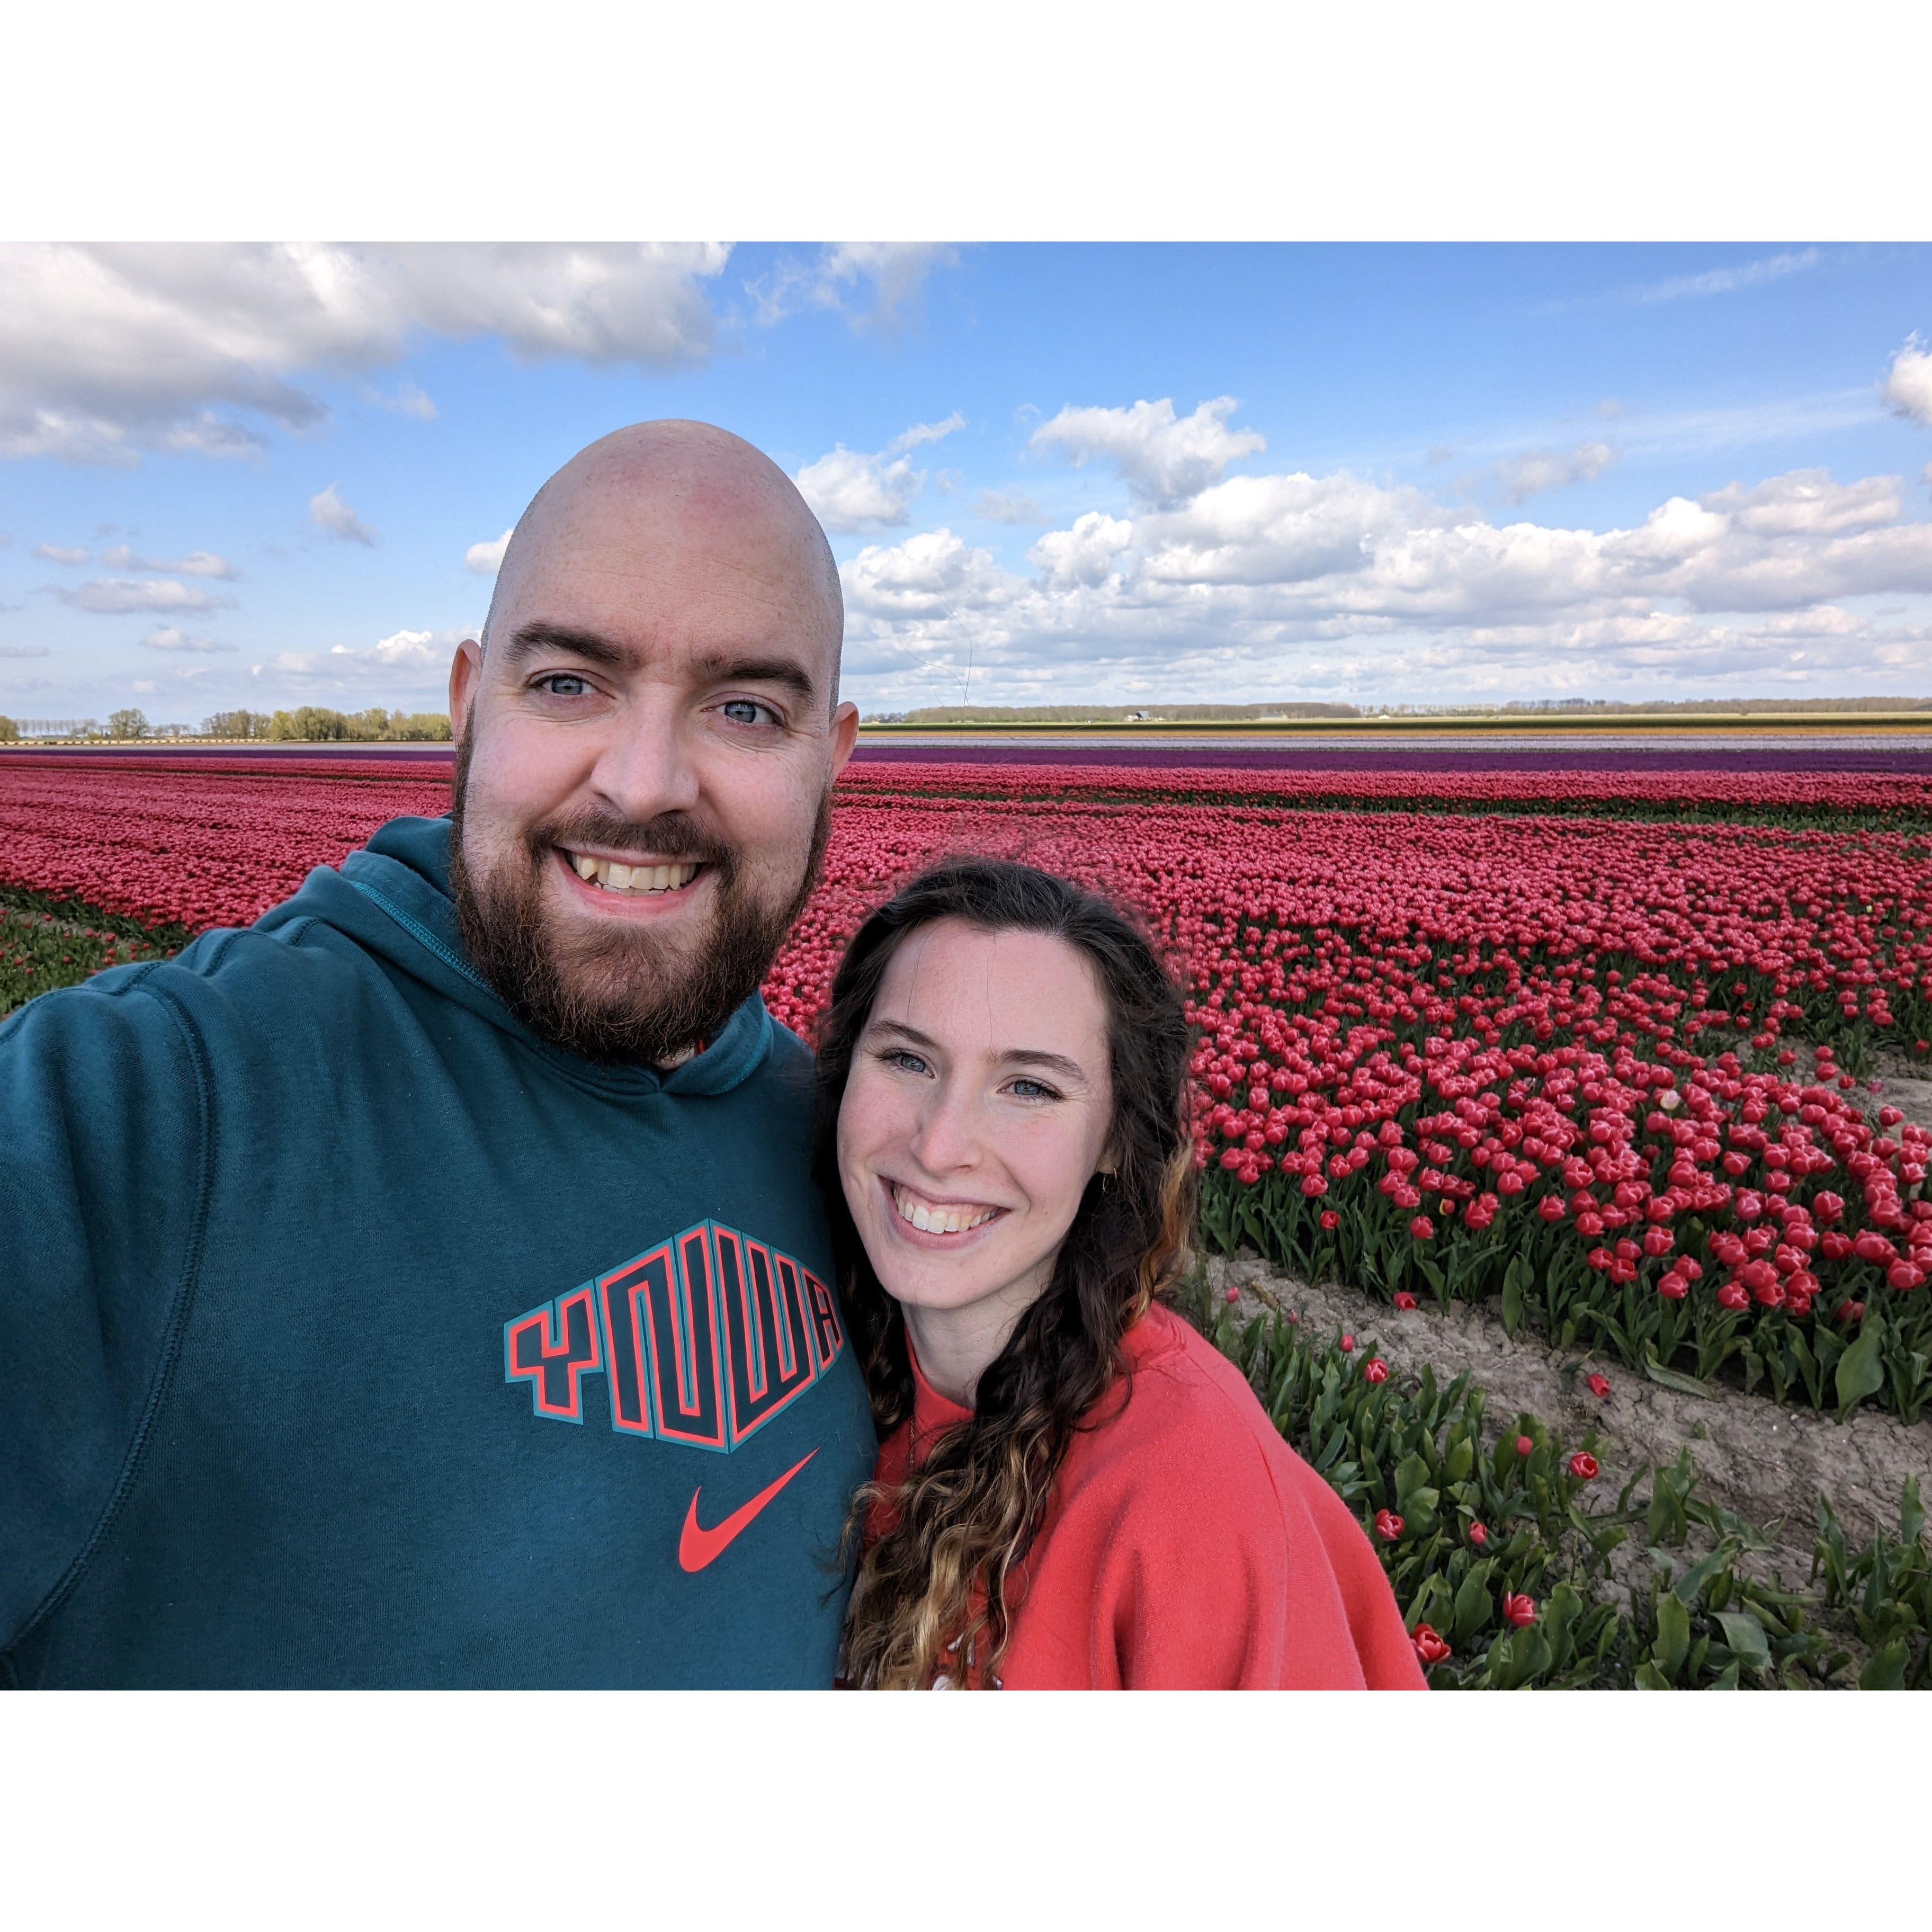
[0,748,1932,1683]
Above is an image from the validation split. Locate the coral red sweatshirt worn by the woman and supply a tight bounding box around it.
[875,1306,1424,1690]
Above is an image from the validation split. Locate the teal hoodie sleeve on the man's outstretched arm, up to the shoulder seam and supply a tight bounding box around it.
[0,968,211,1654]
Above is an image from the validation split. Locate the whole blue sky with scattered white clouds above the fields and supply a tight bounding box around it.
[0,244,1932,722]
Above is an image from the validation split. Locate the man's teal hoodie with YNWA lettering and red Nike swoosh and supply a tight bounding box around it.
[0,819,875,1687]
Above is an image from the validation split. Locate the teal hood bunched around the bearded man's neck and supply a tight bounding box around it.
[257,817,773,1094]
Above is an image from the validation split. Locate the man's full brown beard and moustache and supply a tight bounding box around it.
[450,738,833,1067]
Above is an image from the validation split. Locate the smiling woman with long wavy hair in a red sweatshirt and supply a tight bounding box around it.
[819,860,1422,1688]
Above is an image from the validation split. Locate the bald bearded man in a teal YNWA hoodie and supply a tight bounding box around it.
[0,423,873,1687]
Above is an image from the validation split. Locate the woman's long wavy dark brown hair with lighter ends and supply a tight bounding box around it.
[817,858,1194,1688]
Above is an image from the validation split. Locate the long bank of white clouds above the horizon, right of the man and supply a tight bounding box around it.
[843,455,1932,707]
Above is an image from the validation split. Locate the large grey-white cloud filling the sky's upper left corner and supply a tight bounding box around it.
[0,241,728,464]
